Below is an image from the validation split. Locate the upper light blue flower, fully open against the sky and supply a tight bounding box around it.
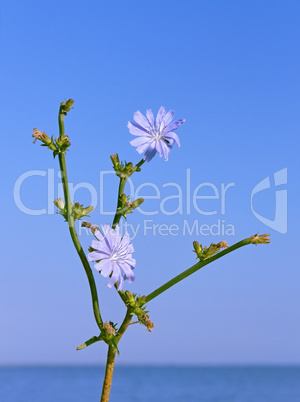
[127,106,185,162]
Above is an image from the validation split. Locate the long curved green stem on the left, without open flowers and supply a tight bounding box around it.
[58,110,103,331]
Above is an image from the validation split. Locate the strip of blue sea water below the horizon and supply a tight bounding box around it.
[0,366,300,402]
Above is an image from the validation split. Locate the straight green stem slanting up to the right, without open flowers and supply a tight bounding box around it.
[146,238,252,303]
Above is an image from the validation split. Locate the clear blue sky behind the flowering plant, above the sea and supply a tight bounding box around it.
[0,0,300,364]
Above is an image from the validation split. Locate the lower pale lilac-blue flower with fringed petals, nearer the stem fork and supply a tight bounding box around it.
[88,225,136,290]
